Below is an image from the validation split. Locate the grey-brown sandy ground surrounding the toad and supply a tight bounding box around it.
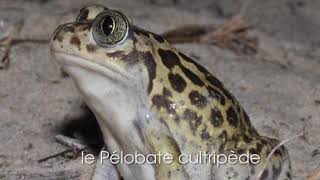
[0,0,320,179]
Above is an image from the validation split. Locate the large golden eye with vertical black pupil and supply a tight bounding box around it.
[92,11,129,46]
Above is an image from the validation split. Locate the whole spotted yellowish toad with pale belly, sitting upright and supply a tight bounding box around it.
[51,5,291,180]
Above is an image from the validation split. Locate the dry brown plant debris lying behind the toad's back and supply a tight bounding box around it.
[162,16,258,54]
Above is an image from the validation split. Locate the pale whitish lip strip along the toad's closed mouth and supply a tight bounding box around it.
[52,51,131,80]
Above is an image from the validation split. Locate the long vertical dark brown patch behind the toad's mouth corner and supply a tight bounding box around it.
[143,52,157,94]
